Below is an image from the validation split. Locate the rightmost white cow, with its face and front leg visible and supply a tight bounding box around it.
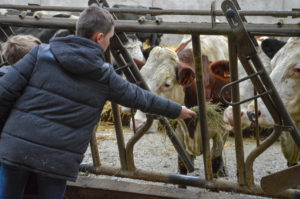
[248,38,300,166]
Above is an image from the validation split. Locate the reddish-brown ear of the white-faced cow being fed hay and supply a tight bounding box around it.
[176,64,195,86]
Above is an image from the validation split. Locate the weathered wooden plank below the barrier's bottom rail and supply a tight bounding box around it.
[65,177,199,199]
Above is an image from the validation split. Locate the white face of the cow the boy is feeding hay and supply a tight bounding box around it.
[131,47,184,132]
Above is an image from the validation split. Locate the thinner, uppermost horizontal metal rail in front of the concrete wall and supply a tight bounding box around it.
[0,4,300,17]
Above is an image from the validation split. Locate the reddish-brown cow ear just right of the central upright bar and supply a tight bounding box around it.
[209,60,230,82]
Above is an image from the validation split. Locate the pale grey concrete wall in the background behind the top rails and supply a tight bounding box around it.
[0,0,300,45]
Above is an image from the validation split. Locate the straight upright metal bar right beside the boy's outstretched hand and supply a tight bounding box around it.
[192,35,213,180]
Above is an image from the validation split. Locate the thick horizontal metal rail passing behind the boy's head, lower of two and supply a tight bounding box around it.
[0,16,300,36]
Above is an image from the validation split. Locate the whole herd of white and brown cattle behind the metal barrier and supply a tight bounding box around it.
[0,6,300,183]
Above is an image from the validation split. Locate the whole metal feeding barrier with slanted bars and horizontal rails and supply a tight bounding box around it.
[0,0,300,198]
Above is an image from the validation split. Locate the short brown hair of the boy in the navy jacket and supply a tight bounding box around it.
[76,4,115,39]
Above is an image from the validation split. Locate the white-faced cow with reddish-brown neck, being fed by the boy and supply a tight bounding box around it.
[135,42,229,176]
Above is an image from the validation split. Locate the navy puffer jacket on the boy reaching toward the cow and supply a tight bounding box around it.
[0,36,181,181]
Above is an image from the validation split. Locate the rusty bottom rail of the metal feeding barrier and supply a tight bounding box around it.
[80,164,300,199]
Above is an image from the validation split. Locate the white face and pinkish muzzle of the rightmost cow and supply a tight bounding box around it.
[249,38,300,126]
